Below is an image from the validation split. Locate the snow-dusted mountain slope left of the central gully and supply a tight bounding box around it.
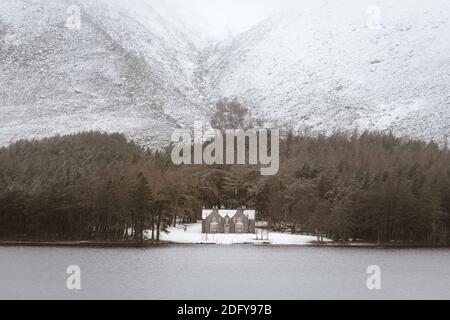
[0,0,204,147]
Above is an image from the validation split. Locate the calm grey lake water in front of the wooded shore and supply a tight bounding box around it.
[0,246,450,300]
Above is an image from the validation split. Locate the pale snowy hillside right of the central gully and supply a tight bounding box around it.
[204,0,450,140]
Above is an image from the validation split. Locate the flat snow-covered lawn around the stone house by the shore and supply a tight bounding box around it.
[148,222,330,245]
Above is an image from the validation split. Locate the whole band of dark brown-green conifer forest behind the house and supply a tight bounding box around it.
[0,102,450,245]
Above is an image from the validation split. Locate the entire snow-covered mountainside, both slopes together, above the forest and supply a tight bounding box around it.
[0,0,450,147]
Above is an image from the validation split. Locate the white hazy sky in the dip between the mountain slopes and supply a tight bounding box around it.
[151,0,280,37]
